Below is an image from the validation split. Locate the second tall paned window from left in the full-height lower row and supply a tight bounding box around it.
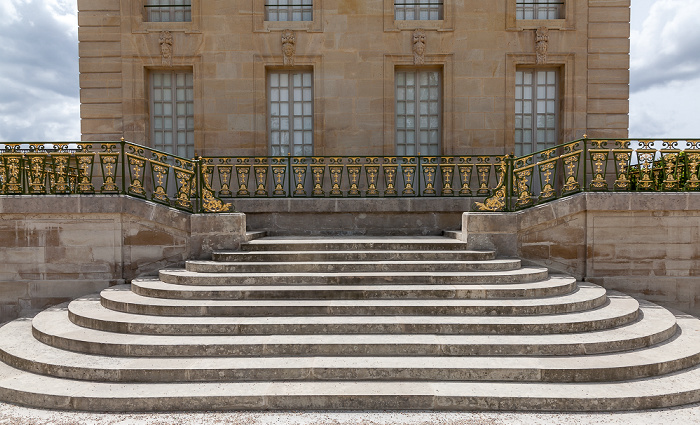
[268,71,314,156]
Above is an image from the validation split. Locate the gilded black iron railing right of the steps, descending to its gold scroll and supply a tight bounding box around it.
[476,138,700,211]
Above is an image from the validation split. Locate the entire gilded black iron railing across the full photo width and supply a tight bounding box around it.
[0,139,700,212]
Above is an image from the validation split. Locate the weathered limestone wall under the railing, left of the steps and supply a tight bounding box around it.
[0,196,245,322]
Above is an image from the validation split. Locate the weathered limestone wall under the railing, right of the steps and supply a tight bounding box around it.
[462,193,700,315]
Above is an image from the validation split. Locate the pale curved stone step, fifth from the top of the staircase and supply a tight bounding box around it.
[131,275,576,300]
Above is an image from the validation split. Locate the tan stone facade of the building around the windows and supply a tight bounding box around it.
[78,0,630,156]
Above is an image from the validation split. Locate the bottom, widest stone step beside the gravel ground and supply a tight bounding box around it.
[0,363,700,412]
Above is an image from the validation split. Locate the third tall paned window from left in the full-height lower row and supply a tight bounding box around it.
[395,70,442,155]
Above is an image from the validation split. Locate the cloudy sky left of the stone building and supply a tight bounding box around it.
[0,0,80,141]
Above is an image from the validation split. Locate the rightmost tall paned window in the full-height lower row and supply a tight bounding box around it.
[515,69,559,156]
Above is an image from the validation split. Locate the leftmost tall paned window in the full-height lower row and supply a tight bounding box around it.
[151,71,194,158]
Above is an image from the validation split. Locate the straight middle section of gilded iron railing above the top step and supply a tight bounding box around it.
[202,155,506,198]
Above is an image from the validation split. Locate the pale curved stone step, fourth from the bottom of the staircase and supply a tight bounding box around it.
[68,292,639,335]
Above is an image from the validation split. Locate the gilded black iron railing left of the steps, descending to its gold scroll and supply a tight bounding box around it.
[0,140,231,212]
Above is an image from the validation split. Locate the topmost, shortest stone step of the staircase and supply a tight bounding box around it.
[241,236,476,251]
